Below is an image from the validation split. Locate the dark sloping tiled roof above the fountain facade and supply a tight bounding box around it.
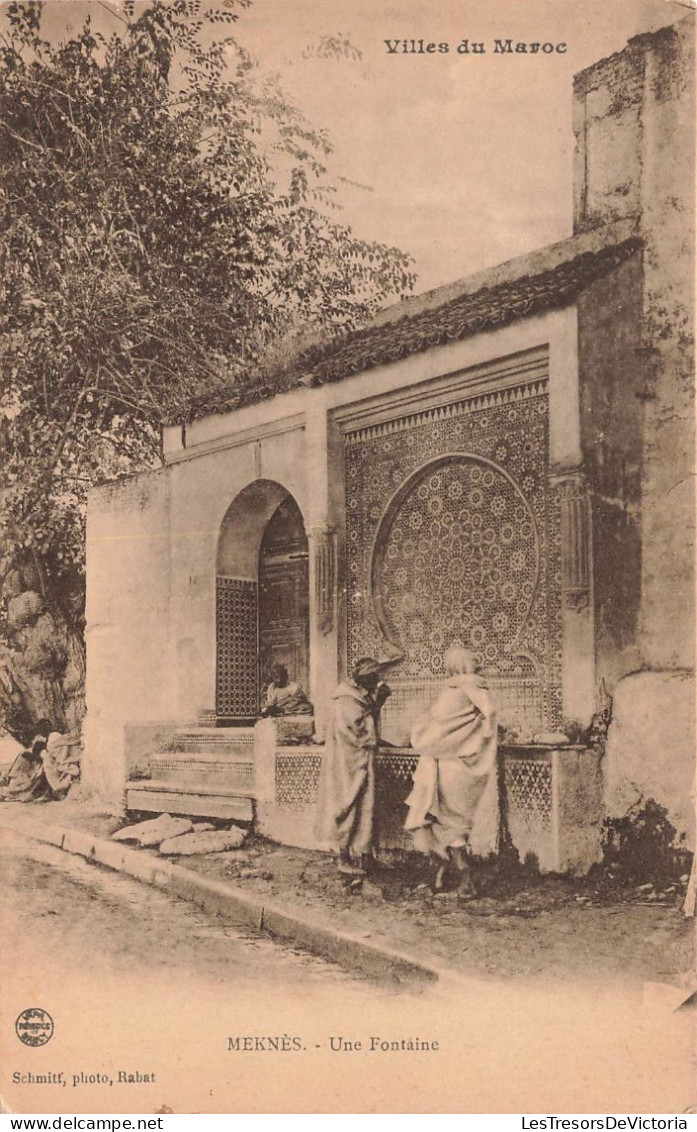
[186,235,642,417]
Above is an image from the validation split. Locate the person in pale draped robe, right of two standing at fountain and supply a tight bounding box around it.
[405,645,499,899]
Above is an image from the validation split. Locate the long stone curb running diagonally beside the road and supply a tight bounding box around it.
[0,816,445,984]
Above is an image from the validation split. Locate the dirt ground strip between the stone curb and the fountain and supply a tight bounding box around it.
[4,799,695,988]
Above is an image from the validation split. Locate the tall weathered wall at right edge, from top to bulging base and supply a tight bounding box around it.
[575,15,695,839]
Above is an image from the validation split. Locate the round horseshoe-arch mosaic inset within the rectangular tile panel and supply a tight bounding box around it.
[370,453,540,661]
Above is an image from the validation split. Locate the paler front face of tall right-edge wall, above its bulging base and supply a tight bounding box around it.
[642,19,695,669]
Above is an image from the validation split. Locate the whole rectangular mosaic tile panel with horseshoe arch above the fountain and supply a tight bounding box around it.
[345,380,561,743]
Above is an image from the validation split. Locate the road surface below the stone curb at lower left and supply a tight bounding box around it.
[0,832,377,994]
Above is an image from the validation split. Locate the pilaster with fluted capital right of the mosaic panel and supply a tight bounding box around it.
[551,469,596,724]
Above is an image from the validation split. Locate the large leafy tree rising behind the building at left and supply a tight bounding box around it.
[0,0,413,731]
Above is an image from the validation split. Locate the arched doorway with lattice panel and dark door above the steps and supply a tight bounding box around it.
[215,480,309,724]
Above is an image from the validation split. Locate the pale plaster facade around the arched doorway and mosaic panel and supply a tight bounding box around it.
[88,294,594,815]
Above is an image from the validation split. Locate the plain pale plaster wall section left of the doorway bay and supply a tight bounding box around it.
[83,470,175,809]
